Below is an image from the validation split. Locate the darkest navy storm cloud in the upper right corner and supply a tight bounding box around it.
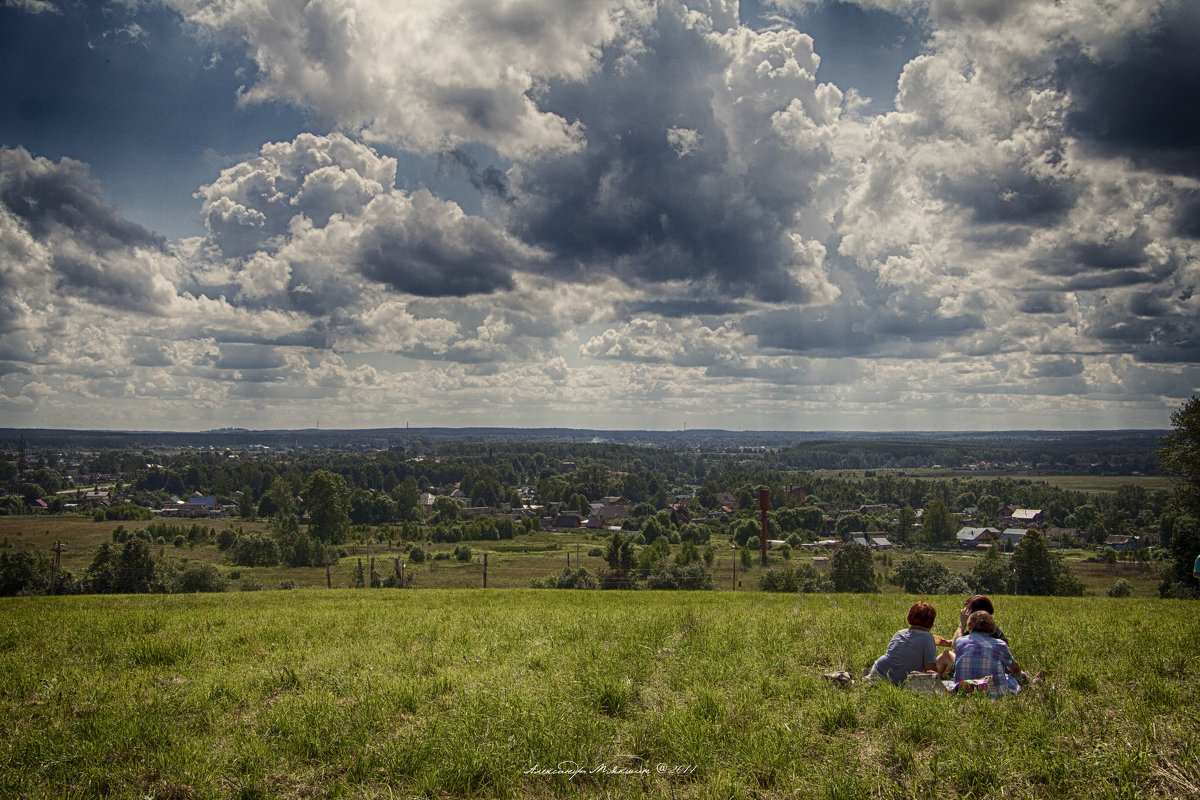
[1057,1,1200,176]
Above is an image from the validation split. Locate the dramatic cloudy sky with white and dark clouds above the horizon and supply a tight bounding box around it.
[0,0,1200,431]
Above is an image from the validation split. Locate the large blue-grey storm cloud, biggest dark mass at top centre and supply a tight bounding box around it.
[509,10,832,302]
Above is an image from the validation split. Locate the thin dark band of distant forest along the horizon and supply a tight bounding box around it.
[0,428,1168,475]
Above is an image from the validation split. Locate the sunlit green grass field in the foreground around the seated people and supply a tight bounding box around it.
[0,590,1200,799]
